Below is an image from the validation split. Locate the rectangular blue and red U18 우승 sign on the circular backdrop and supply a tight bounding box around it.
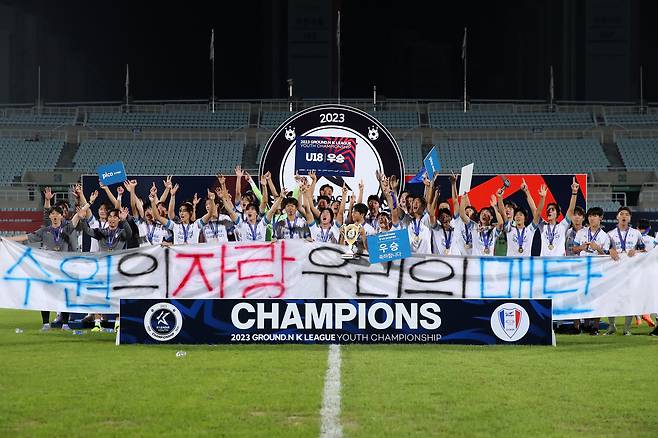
[295,135,356,177]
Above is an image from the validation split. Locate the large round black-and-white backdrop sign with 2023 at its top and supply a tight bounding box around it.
[259,104,404,201]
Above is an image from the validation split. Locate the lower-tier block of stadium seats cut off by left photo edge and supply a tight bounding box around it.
[0,138,64,183]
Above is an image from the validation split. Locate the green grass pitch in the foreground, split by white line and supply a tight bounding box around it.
[0,310,658,437]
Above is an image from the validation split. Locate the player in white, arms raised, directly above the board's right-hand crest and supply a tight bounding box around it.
[496,181,548,257]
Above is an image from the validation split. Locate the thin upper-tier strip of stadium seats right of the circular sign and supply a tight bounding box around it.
[429,111,596,129]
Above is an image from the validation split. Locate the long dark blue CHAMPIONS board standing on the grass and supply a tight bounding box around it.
[119,299,553,345]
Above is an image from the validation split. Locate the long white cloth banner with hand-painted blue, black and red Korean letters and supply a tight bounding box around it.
[0,240,658,319]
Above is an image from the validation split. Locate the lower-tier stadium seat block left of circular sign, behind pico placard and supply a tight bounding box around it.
[73,140,245,175]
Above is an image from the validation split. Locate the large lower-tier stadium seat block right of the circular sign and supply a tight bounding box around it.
[437,138,609,173]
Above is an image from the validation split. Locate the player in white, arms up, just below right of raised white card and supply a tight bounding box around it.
[459,193,503,256]
